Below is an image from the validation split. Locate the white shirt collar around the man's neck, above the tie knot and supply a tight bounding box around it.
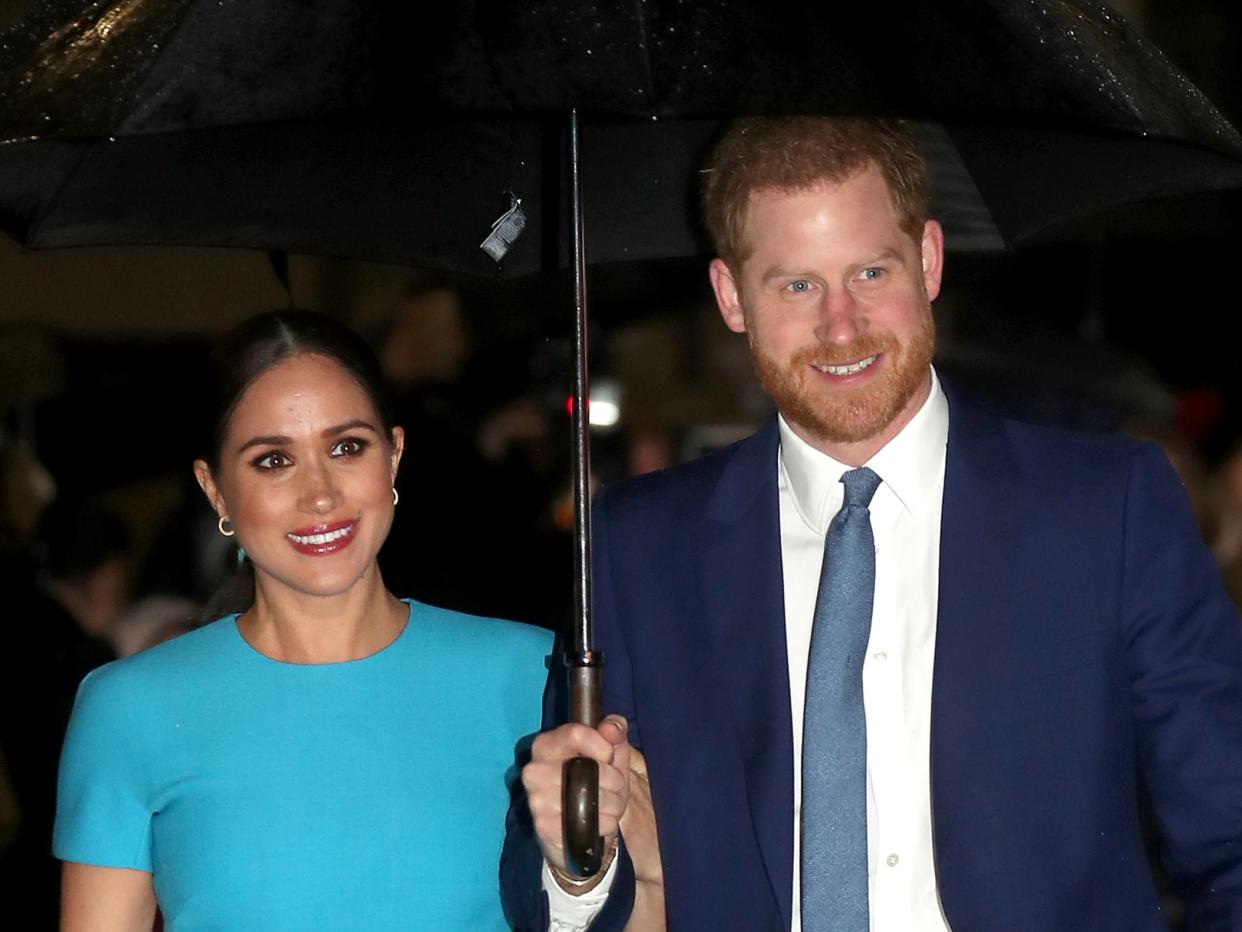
[777,369,949,532]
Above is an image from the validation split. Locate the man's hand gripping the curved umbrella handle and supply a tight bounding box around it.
[522,715,633,893]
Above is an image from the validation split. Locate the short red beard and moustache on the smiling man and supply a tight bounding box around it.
[750,308,935,444]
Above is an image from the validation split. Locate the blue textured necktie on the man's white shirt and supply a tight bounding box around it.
[801,467,881,932]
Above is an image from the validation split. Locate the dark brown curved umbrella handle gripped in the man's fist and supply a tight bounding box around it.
[560,651,604,877]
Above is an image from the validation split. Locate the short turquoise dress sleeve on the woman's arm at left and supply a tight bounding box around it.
[52,664,152,871]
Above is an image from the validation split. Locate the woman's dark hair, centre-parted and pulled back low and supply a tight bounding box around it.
[202,311,395,621]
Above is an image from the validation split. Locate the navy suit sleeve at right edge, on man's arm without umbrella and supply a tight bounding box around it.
[1122,447,1242,932]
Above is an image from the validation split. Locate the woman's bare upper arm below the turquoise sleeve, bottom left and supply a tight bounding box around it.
[61,861,155,932]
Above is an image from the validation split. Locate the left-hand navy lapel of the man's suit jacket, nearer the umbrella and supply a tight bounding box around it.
[696,420,794,928]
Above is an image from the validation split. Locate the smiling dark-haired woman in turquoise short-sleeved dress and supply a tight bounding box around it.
[55,313,550,932]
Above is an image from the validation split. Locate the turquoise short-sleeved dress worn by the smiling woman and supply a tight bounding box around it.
[53,601,551,932]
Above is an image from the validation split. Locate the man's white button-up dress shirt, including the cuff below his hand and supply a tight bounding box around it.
[543,372,949,932]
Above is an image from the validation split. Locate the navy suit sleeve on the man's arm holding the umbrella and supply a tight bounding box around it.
[501,491,641,932]
